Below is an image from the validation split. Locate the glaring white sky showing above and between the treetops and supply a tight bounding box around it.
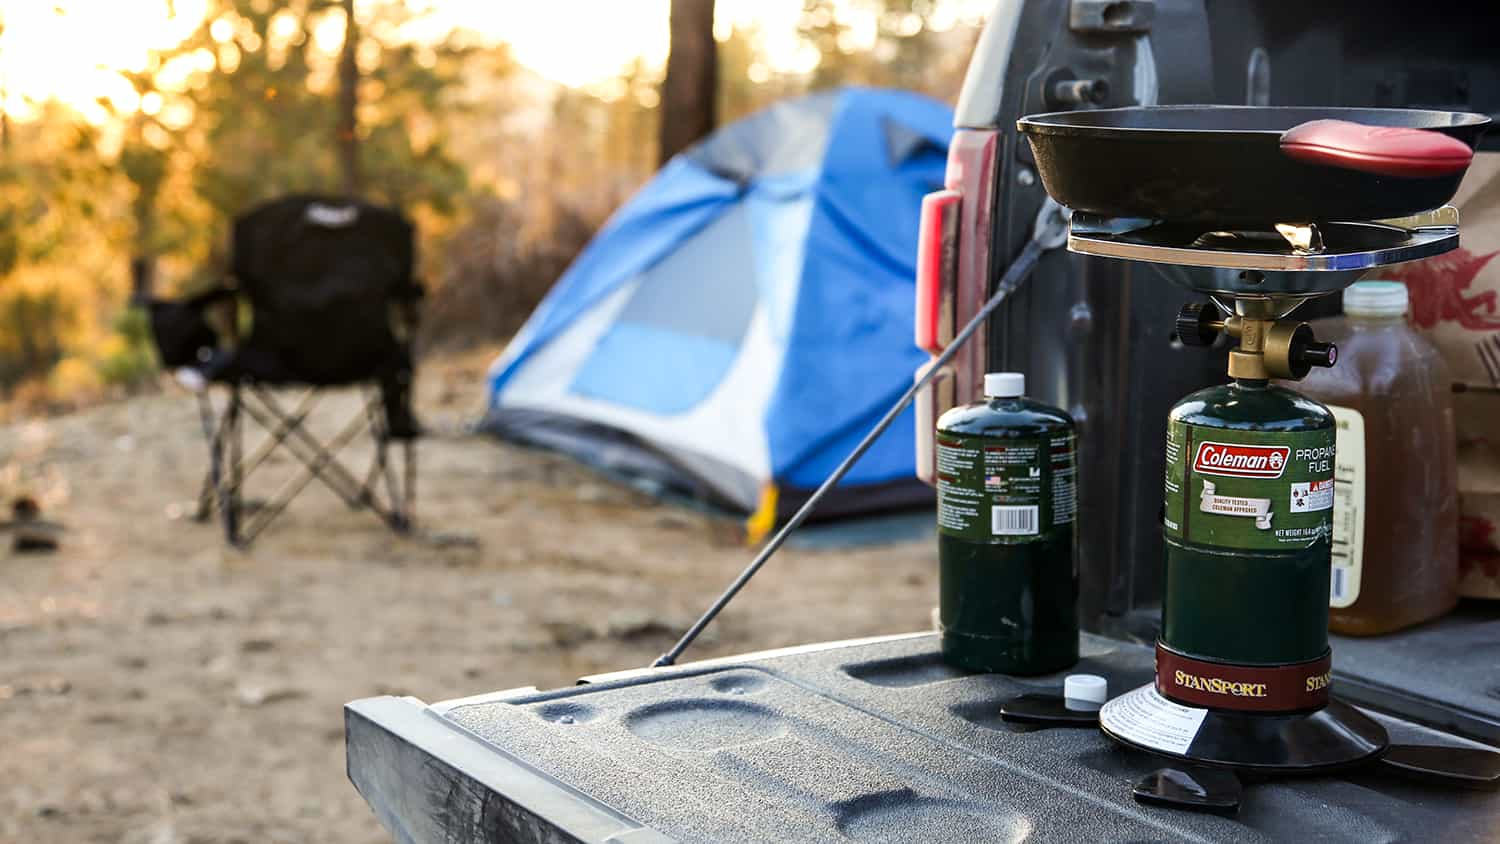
[0,0,990,123]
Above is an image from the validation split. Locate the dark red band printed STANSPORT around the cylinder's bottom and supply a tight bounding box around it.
[1157,642,1334,712]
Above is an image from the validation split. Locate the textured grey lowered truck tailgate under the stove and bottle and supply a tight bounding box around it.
[345,626,1500,843]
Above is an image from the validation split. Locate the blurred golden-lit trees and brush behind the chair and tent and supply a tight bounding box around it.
[0,0,983,415]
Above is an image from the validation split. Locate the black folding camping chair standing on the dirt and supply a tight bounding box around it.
[137,196,423,547]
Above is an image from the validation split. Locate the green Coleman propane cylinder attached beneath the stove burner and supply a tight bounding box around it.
[1158,379,1335,709]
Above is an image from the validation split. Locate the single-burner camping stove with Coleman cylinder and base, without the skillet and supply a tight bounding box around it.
[1068,207,1458,772]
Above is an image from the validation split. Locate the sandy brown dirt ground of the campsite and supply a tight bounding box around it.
[0,346,936,844]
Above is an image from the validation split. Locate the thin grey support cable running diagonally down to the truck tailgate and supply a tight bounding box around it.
[651,238,1043,669]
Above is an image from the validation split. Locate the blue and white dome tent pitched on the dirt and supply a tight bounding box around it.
[485,88,953,526]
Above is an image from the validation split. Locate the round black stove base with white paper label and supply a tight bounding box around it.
[1100,685,1389,775]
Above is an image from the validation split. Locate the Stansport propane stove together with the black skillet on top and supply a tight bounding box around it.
[1017,106,1493,798]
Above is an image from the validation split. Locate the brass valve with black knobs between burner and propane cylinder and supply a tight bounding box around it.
[1176,304,1338,381]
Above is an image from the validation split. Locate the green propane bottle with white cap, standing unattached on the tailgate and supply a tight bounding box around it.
[936,372,1079,675]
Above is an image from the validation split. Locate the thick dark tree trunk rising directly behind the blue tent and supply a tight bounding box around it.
[657,0,719,163]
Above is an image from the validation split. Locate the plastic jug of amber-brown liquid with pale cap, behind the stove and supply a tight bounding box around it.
[1301,282,1458,636]
